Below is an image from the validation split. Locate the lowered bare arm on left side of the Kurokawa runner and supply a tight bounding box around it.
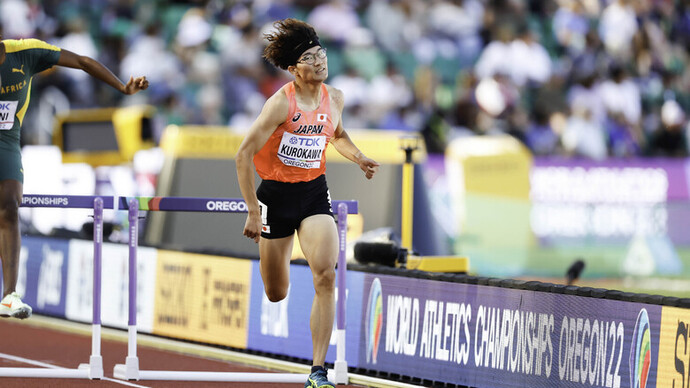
[235,89,290,243]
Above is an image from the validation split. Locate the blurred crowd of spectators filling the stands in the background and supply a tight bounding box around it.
[0,0,690,160]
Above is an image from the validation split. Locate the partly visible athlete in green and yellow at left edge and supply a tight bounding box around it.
[0,39,148,319]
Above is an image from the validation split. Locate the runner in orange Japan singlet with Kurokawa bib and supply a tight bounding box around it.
[236,19,379,387]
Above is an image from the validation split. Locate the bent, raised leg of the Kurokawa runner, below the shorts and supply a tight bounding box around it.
[259,235,294,302]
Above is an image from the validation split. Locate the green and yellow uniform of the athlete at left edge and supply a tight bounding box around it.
[0,39,60,182]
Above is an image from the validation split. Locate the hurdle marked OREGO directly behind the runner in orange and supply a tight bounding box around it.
[113,197,358,384]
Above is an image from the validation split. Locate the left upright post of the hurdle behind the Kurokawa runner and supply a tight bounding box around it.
[113,198,140,380]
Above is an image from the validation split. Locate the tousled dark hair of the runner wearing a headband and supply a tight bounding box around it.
[263,18,321,70]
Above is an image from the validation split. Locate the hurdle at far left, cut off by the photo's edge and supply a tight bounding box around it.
[0,195,109,380]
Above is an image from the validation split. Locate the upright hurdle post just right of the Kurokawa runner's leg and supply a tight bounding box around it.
[333,203,348,384]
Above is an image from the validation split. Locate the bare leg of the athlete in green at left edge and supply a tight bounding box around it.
[0,179,23,297]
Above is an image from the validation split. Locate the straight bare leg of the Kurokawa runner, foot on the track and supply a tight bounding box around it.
[297,214,338,366]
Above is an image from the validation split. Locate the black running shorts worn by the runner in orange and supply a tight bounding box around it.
[256,175,333,239]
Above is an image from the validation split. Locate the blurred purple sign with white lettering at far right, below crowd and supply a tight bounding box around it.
[530,158,690,245]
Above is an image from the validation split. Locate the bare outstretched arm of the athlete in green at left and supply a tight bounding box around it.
[57,49,149,94]
